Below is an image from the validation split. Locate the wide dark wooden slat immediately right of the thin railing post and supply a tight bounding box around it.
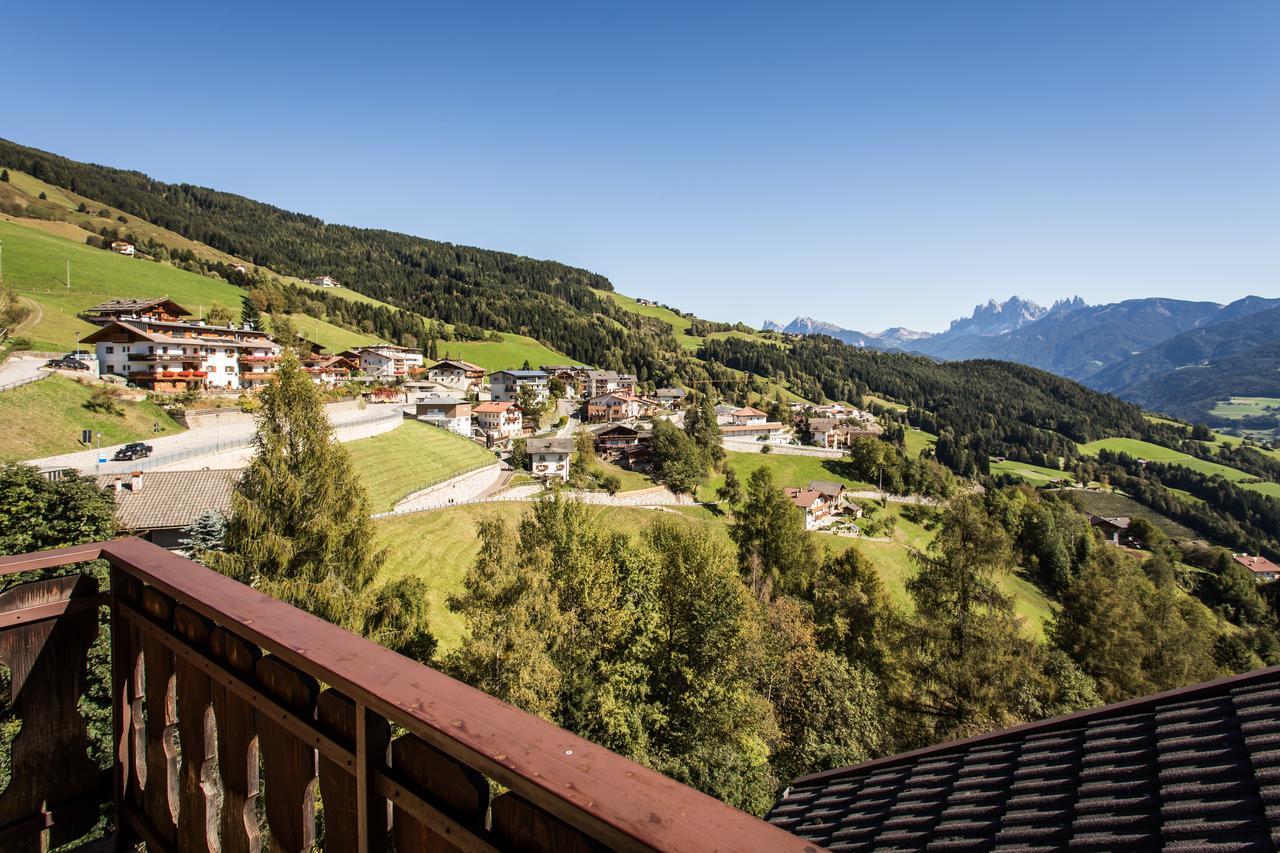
[392,735,489,853]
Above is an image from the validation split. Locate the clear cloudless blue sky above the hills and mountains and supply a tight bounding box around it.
[0,0,1280,330]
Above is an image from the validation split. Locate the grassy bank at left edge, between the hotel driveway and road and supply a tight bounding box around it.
[0,376,182,462]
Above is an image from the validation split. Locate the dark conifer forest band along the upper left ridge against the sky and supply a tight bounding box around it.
[0,140,703,380]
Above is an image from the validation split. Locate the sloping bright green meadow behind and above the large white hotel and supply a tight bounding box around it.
[0,220,252,351]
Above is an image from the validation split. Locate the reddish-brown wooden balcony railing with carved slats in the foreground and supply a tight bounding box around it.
[0,539,817,853]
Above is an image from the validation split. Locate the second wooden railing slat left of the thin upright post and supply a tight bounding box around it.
[255,657,319,853]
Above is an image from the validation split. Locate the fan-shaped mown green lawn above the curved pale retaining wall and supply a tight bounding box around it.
[343,420,498,512]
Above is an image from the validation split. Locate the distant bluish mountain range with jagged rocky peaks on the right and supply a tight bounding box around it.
[764,296,1280,418]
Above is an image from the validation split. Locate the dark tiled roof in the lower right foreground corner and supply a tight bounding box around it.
[767,667,1280,850]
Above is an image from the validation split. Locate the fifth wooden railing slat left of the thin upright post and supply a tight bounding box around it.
[142,588,178,844]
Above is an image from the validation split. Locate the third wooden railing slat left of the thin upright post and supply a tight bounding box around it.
[209,628,262,853]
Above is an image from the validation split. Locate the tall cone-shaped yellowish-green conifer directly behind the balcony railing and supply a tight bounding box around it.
[209,350,434,656]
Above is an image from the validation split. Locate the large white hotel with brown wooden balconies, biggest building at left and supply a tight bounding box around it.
[81,300,282,393]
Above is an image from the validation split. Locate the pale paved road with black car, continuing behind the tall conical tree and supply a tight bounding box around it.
[28,403,403,474]
